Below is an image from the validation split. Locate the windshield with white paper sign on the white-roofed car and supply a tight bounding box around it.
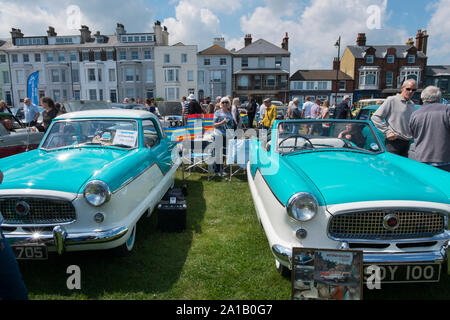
[41,119,139,150]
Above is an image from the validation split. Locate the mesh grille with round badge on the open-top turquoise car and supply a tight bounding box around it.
[328,210,446,240]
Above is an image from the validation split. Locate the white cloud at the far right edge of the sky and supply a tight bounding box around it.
[427,0,450,64]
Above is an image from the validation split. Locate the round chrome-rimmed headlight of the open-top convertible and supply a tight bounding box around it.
[287,192,319,221]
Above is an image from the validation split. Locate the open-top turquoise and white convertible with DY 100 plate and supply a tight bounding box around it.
[247,120,450,282]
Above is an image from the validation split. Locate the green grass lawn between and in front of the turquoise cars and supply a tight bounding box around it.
[16,172,450,300]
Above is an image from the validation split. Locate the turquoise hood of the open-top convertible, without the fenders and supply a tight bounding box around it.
[285,151,449,205]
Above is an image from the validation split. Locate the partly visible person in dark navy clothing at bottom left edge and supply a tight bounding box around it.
[0,212,28,300]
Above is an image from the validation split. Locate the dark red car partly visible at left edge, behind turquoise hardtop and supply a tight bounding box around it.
[0,113,44,158]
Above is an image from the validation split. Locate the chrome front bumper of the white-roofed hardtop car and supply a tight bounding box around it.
[5,226,128,254]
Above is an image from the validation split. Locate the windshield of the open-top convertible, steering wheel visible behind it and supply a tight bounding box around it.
[277,121,383,154]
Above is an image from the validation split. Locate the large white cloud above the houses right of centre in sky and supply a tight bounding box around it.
[238,0,412,73]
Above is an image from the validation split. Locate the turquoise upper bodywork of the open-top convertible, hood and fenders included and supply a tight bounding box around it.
[250,119,450,206]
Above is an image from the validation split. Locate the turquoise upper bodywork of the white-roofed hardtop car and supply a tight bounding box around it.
[0,117,175,193]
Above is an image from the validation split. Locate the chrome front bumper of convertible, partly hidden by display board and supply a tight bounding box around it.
[272,241,450,266]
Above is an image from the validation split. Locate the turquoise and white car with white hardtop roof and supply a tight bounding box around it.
[0,110,179,259]
